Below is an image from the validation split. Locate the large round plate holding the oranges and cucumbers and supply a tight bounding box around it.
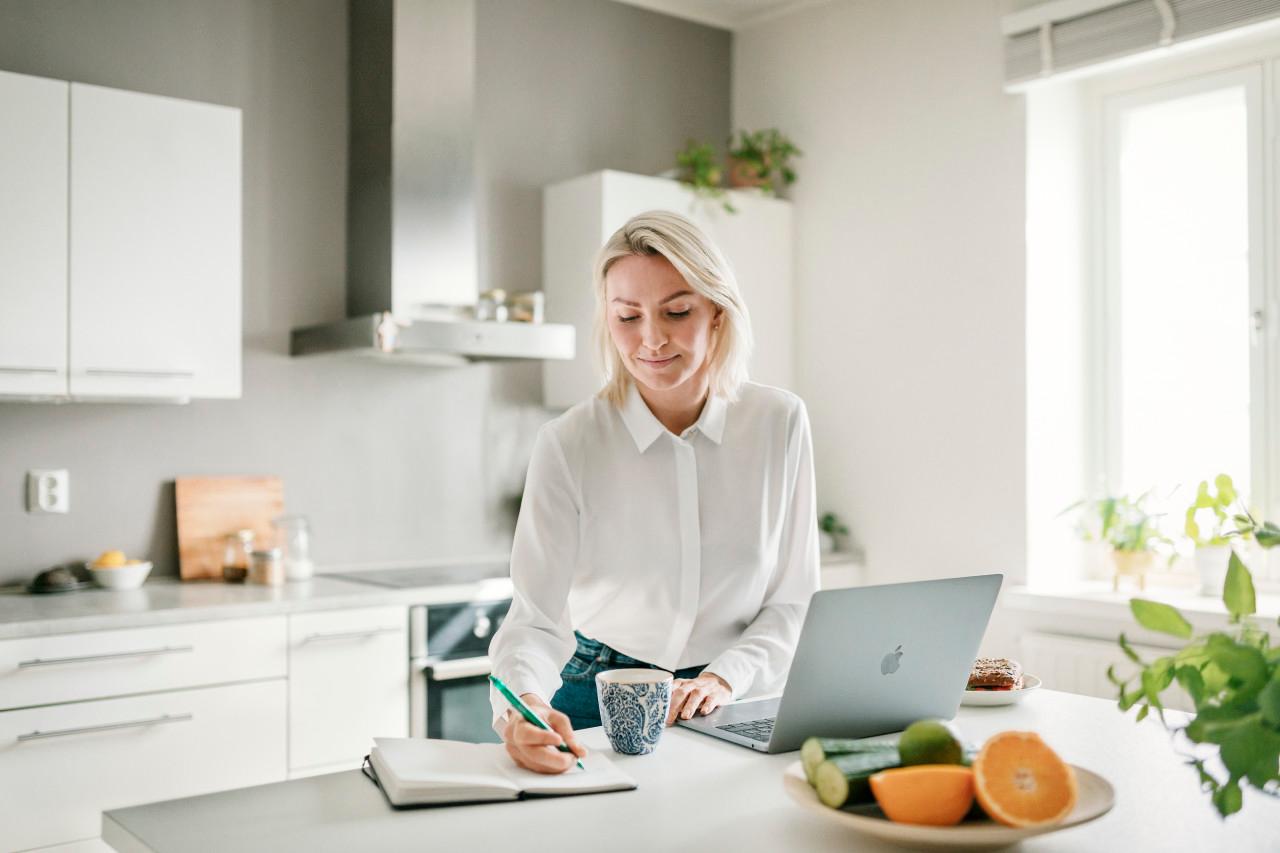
[782,761,1116,850]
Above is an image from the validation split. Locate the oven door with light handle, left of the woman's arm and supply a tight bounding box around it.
[421,657,500,743]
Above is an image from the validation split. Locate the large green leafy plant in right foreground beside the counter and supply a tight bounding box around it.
[1107,512,1280,817]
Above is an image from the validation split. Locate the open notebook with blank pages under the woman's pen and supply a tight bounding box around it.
[366,738,636,807]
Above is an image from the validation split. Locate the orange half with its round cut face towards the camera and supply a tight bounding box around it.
[973,731,1076,826]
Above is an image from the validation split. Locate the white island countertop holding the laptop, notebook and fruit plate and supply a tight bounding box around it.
[102,690,1280,853]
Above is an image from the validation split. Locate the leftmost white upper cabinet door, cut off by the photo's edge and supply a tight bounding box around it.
[0,72,69,397]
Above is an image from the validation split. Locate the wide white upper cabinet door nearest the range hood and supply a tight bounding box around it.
[69,83,241,398]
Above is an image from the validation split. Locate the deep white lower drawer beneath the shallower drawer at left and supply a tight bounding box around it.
[0,679,287,850]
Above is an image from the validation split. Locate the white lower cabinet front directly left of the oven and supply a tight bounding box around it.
[289,607,408,777]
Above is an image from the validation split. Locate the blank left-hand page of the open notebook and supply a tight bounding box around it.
[374,738,520,802]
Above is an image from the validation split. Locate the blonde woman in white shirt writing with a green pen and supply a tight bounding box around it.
[489,211,818,772]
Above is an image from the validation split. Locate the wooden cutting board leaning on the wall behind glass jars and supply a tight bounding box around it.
[174,476,284,580]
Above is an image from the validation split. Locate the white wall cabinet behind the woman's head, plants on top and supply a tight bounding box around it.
[543,170,795,409]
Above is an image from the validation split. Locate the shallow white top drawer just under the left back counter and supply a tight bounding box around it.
[0,616,288,710]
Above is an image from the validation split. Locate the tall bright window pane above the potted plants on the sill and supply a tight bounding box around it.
[1093,68,1266,504]
